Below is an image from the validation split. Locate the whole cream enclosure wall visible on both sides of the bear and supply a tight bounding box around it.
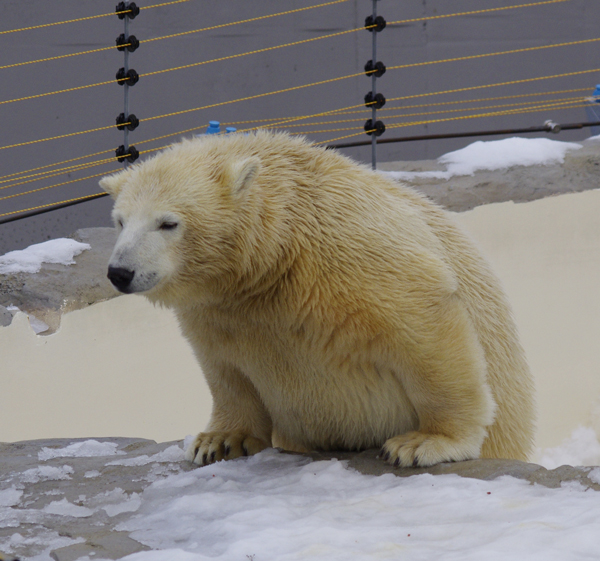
[0,191,600,448]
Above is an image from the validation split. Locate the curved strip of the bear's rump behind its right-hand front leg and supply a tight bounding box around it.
[392,184,535,460]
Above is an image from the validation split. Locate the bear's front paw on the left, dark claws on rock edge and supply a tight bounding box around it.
[185,432,269,466]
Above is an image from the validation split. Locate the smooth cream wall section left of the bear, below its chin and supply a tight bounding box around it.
[0,295,211,442]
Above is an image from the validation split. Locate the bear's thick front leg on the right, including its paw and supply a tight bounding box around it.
[381,296,495,467]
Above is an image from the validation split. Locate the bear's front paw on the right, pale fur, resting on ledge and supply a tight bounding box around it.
[379,432,481,467]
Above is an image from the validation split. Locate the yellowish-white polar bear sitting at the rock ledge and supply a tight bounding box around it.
[100,132,534,466]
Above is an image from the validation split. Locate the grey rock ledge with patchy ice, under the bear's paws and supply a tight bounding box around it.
[0,438,600,561]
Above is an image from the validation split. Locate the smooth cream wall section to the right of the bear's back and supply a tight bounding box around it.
[456,190,600,456]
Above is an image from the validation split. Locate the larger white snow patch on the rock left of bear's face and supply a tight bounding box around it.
[0,238,92,275]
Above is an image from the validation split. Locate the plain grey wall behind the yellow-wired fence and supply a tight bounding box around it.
[0,0,600,254]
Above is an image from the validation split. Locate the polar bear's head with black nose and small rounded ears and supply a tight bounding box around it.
[100,141,261,303]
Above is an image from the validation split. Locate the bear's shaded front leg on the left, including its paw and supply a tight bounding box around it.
[185,366,272,465]
